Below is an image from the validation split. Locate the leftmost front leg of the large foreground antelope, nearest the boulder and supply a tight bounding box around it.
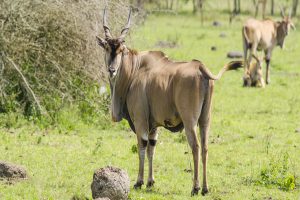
[134,132,148,189]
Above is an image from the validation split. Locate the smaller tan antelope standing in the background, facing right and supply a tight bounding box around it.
[242,9,295,86]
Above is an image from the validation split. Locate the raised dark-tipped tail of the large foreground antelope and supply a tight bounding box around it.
[200,61,244,80]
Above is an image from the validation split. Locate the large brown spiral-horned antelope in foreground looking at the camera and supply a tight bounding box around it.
[97,9,243,195]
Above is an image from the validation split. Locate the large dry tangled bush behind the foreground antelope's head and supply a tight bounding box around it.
[0,0,135,128]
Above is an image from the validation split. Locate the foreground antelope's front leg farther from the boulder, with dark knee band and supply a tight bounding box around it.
[147,129,158,187]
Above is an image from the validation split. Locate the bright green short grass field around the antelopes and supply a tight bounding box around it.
[0,4,300,200]
